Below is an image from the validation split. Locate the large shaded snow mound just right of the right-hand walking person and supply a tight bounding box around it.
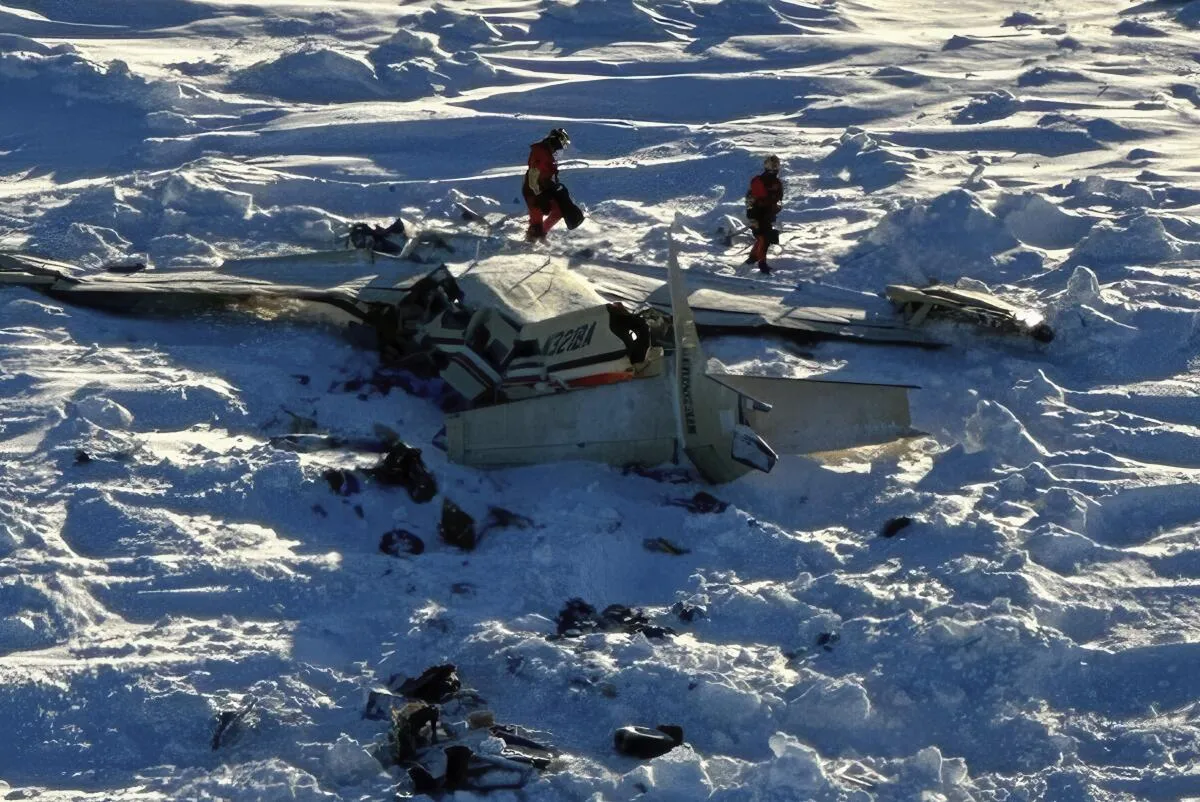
[838,190,1040,289]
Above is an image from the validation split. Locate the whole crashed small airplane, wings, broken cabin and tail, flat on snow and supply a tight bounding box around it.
[0,219,1051,484]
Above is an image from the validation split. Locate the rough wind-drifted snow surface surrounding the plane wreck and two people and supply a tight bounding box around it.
[0,0,1200,802]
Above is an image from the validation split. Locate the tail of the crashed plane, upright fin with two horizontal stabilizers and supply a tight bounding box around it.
[446,243,911,484]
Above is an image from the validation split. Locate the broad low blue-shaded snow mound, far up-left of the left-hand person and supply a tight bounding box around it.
[229,48,382,103]
